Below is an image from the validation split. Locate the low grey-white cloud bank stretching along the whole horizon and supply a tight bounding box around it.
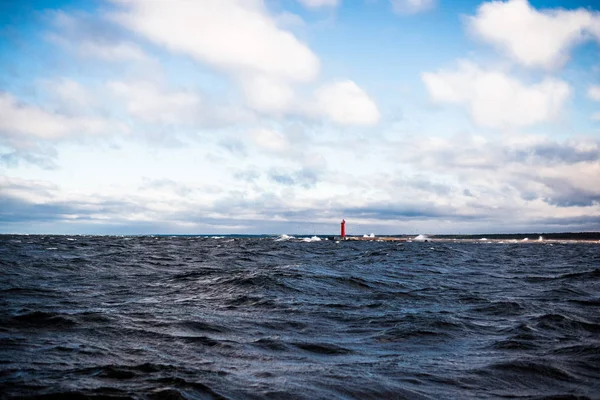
[0,129,600,234]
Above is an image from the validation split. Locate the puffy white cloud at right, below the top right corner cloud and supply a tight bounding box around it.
[421,61,571,128]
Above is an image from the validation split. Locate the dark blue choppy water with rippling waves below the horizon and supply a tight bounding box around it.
[0,236,600,399]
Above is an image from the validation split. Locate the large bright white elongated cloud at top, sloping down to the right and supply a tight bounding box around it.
[114,0,319,82]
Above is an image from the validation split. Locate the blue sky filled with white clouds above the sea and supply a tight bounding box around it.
[0,0,600,235]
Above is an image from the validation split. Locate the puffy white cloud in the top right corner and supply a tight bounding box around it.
[468,0,600,69]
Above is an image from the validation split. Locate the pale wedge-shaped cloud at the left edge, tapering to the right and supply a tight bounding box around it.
[0,93,124,140]
